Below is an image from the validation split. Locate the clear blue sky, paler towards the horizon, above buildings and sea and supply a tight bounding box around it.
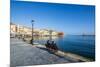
[11,1,95,35]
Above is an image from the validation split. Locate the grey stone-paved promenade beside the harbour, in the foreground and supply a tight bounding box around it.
[10,38,76,67]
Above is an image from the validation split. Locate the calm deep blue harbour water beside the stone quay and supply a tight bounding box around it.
[35,35,95,60]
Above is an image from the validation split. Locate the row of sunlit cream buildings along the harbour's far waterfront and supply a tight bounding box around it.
[10,23,62,36]
